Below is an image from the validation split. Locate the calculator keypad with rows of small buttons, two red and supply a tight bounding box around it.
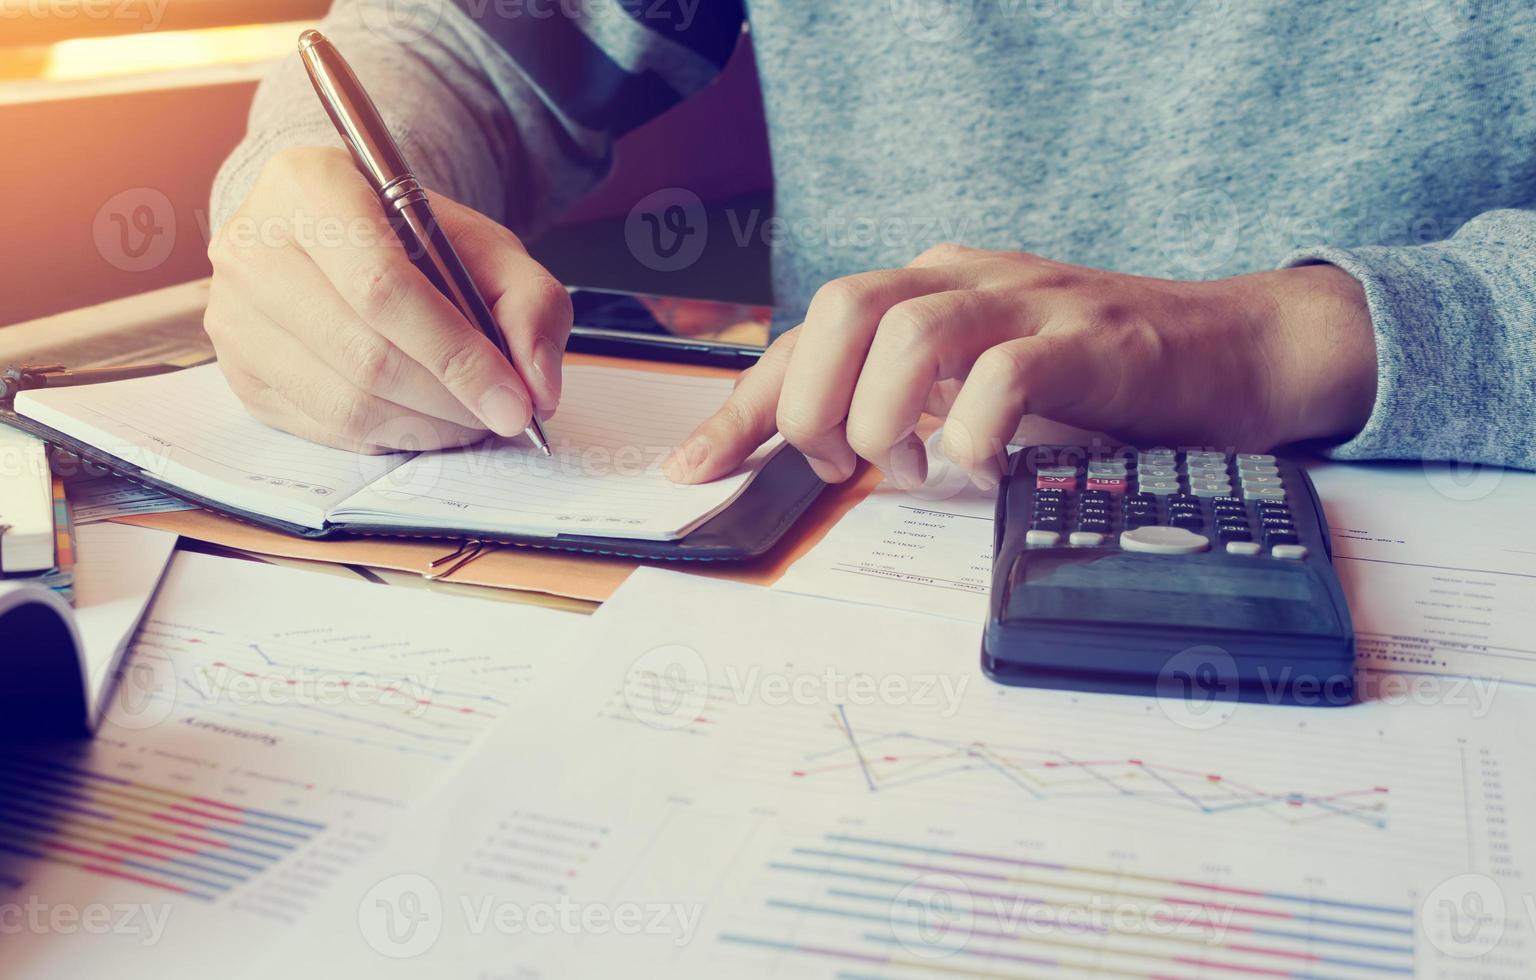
[1026,449,1307,561]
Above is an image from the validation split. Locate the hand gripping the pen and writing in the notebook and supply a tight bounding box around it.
[204,147,571,452]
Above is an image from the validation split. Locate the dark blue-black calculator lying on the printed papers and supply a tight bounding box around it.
[982,445,1355,705]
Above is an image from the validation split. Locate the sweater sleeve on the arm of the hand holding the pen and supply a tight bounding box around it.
[210,0,743,237]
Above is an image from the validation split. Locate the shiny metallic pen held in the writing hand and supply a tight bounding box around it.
[298,31,553,456]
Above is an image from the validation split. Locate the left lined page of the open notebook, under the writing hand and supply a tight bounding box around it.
[15,364,410,528]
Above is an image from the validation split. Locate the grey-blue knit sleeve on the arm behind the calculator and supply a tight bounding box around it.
[1284,209,1536,470]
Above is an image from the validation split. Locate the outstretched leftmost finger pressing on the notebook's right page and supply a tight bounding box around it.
[662,327,799,484]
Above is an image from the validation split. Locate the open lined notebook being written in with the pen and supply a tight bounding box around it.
[3,366,814,558]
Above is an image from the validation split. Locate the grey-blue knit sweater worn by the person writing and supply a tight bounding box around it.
[214,0,1536,468]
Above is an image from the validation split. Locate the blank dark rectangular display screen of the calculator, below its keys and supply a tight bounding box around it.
[1008,551,1339,634]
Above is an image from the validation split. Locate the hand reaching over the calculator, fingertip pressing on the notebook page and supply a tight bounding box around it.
[667,246,1376,488]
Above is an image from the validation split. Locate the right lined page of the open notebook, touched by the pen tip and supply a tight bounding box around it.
[332,367,782,541]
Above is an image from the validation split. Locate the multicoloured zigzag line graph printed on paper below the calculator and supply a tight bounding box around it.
[791,705,1390,829]
